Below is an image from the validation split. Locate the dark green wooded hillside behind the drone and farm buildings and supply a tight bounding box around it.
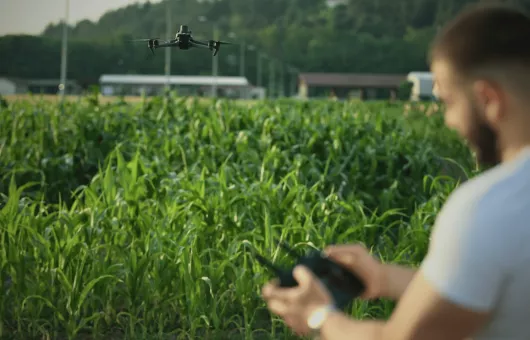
[0,0,530,88]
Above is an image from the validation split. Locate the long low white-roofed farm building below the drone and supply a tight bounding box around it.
[99,74,265,99]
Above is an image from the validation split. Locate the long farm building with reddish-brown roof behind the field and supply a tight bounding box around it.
[298,73,407,100]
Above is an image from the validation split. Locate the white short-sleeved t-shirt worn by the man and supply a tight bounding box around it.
[421,147,530,340]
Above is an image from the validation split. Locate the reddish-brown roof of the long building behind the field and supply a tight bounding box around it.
[300,73,407,88]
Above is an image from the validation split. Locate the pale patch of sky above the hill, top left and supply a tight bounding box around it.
[0,0,159,36]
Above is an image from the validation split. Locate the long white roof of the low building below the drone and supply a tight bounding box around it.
[99,74,250,86]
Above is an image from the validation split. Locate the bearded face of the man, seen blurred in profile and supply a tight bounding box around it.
[431,60,501,166]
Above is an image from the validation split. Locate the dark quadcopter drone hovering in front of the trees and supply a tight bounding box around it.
[134,25,232,57]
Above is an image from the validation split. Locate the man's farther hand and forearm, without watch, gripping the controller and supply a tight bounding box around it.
[324,244,416,300]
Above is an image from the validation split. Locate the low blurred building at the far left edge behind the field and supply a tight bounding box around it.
[0,77,81,95]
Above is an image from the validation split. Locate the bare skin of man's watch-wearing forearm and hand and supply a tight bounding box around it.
[263,258,490,340]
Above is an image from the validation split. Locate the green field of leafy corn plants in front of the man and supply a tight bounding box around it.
[0,97,477,340]
